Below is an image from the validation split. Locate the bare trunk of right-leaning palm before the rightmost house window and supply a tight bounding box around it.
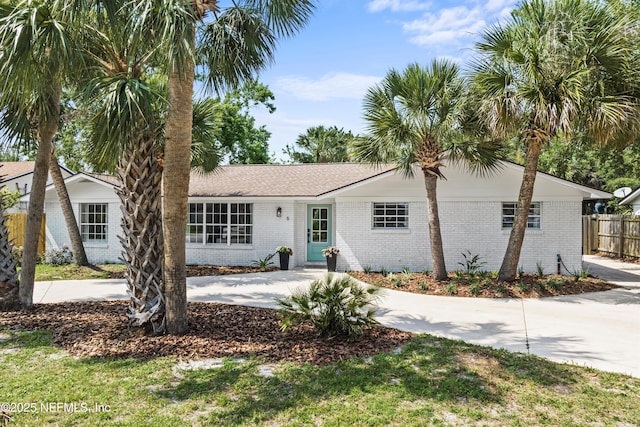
[498,131,542,282]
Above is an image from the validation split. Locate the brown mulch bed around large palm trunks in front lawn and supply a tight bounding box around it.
[0,301,414,365]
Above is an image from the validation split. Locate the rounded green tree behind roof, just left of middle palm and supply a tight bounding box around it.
[282,126,355,163]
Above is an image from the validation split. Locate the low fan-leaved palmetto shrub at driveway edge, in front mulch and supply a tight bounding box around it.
[278,274,381,338]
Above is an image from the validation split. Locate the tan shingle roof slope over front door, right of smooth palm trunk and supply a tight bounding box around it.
[189,163,394,197]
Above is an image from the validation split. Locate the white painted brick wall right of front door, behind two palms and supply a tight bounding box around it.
[336,200,582,273]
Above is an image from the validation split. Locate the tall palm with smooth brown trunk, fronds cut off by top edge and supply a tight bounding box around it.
[134,0,314,334]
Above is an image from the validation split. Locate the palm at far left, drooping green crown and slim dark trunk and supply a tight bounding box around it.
[0,0,85,308]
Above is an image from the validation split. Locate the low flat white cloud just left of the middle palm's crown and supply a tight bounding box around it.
[274,73,382,101]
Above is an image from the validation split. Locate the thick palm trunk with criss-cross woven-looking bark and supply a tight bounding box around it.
[117,132,165,335]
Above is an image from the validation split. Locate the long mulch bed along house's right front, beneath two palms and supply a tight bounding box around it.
[349,271,619,298]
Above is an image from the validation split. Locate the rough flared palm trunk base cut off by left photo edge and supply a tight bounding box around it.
[0,189,20,310]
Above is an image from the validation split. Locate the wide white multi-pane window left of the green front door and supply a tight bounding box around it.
[187,203,253,245]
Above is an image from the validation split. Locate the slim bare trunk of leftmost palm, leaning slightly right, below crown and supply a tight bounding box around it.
[20,84,61,309]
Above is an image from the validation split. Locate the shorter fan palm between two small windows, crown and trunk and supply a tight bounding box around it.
[352,60,497,280]
